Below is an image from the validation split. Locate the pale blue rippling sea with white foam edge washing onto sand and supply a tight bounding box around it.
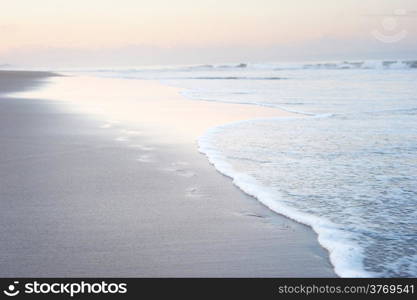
[76,60,417,277]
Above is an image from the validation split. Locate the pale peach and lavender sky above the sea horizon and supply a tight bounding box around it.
[0,0,417,66]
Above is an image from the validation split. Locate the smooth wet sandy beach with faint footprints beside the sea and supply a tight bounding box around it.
[0,72,335,277]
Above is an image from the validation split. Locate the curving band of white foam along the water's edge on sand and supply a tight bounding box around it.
[198,121,373,277]
